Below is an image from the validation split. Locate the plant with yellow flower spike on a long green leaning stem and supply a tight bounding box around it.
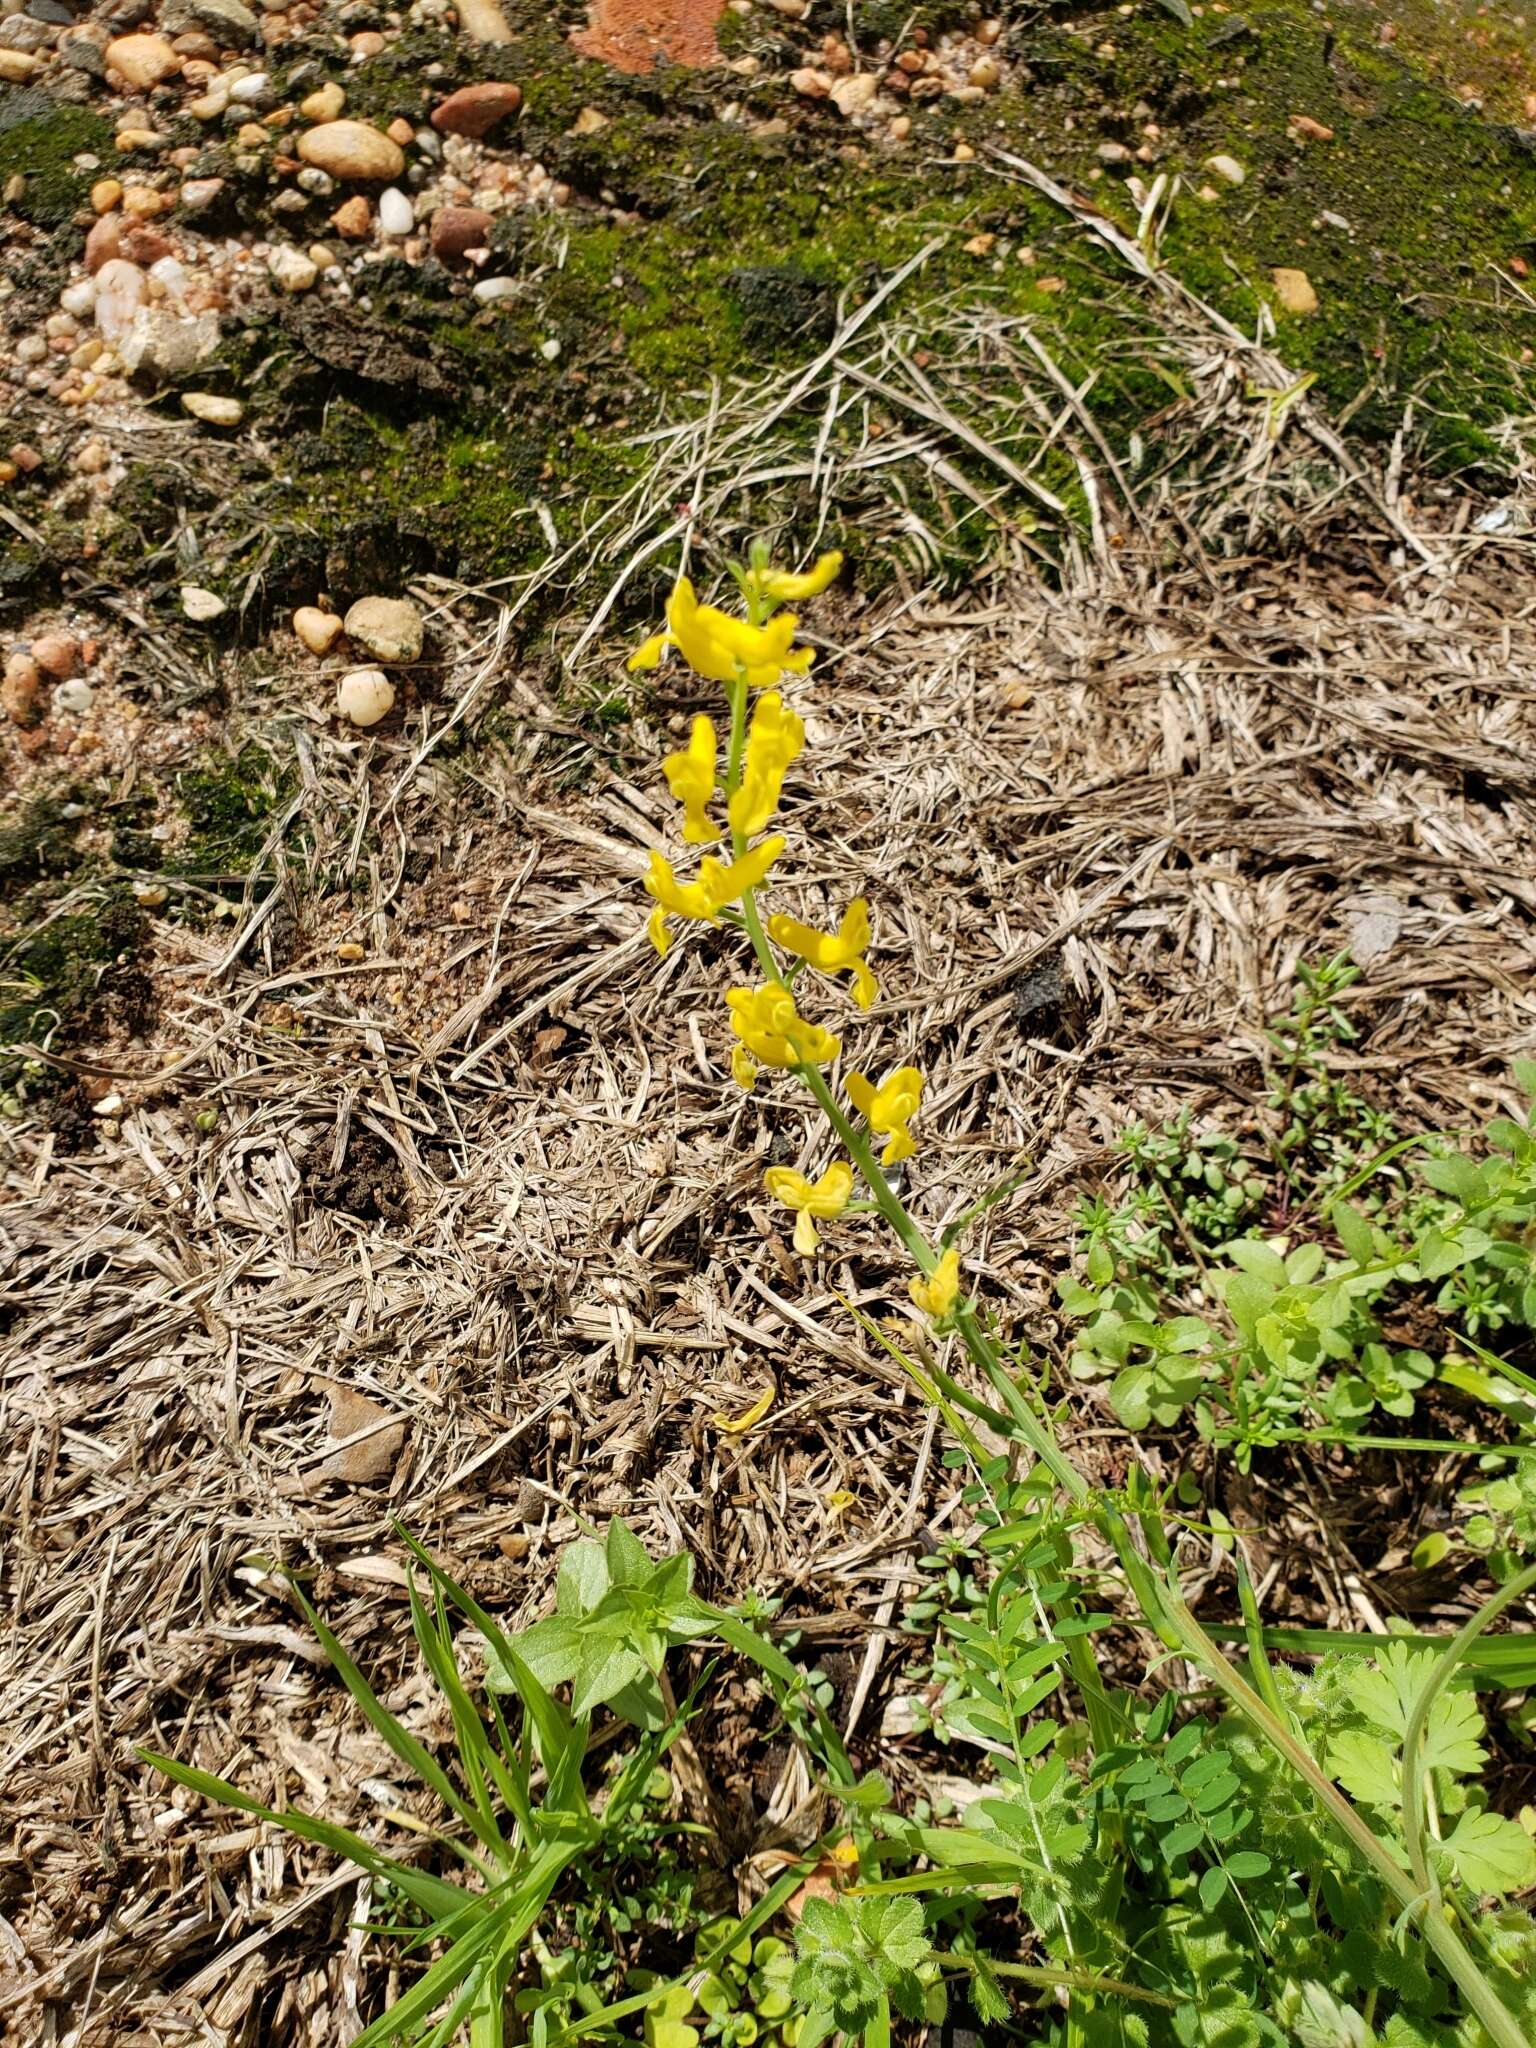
[629,543,1536,2048]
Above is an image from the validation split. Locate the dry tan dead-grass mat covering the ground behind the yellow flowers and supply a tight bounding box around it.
[0,0,1536,2048]
